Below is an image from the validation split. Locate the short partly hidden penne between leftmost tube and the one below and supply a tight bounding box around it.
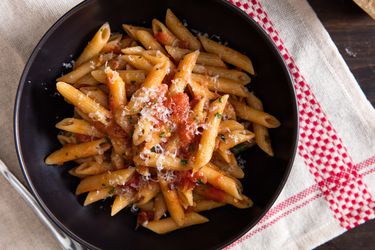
[69,161,111,178]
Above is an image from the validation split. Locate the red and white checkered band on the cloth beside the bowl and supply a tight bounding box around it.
[229,0,375,229]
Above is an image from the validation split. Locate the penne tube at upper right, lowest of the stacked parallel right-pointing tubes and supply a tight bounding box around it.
[191,73,249,97]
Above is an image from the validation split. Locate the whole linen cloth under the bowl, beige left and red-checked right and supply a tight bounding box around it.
[0,0,375,249]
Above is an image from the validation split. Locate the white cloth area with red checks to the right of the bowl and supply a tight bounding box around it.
[229,0,375,249]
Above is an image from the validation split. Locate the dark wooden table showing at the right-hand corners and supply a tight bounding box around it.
[308,0,375,250]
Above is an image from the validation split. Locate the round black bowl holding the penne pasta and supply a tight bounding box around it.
[14,0,298,249]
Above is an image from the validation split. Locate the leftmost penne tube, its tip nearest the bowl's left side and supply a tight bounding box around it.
[45,139,111,165]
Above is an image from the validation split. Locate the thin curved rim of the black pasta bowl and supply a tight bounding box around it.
[13,0,299,249]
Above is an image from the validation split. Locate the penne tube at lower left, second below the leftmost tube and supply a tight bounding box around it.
[76,168,135,195]
